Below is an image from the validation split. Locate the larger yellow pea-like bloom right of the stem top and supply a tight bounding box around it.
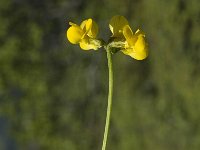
[109,16,148,60]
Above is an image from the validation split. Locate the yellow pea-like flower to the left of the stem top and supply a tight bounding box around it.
[66,19,101,50]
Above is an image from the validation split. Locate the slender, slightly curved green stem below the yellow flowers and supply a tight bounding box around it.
[102,48,113,150]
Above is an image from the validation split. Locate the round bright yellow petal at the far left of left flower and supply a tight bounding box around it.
[67,26,84,44]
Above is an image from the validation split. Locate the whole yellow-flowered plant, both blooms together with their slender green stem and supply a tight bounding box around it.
[66,15,148,150]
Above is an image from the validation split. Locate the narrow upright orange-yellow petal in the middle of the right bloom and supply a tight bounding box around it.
[123,25,137,47]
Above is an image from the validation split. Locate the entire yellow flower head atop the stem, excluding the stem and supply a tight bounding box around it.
[67,15,148,60]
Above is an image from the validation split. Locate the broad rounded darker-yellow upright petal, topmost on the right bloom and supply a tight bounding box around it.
[109,15,128,37]
